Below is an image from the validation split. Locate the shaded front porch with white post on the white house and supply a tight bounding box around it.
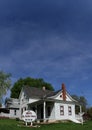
[28,101,55,122]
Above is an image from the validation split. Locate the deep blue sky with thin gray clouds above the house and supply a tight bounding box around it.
[0,0,92,106]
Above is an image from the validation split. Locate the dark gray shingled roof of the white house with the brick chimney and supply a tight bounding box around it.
[23,86,77,103]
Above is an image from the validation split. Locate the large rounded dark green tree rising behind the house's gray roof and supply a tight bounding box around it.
[11,77,54,98]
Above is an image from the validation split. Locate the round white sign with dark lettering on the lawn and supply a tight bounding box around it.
[22,110,37,125]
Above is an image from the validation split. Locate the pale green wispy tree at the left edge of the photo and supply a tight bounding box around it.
[0,71,11,102]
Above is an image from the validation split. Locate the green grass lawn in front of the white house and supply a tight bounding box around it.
[0,119,92,130]
